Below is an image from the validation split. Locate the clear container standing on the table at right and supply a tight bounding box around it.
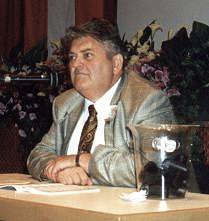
[128,124,199,200]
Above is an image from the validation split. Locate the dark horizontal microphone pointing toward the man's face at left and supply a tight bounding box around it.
[0,72,64,88]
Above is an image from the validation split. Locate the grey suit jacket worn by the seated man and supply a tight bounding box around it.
[27,73,174,187]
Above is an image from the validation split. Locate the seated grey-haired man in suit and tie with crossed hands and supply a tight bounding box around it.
[28,19,176,186]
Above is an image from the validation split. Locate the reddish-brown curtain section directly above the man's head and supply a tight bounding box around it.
[75,0,117,25]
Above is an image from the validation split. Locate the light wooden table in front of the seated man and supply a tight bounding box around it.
[0,174,209,221]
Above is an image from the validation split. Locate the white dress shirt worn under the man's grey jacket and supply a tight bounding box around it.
[67,79,120,155]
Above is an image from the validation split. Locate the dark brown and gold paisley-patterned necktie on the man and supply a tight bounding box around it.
[78,105,97,153]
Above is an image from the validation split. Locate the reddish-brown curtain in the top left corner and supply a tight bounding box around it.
[0,0,47,57]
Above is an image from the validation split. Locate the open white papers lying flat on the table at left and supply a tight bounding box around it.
[0,183,100,195]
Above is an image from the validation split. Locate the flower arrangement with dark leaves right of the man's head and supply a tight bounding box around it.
[125,21,209,123]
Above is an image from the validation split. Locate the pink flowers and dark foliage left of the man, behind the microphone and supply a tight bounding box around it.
[0,44,71,155]
